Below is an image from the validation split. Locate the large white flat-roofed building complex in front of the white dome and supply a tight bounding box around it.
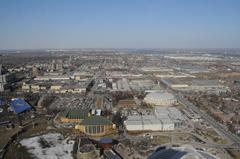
[124,107,184,131]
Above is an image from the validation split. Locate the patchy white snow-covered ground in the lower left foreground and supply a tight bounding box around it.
[20,133,74,159]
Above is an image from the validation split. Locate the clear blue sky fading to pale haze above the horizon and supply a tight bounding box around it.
[0,0,240,49]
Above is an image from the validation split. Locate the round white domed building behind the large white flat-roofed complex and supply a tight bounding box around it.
[144,91,177,106]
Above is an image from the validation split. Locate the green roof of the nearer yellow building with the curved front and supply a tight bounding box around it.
[81,116,112,125]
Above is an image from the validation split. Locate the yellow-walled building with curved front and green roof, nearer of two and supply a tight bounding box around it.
[75,116,115,136]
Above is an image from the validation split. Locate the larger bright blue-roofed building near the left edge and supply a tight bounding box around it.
[11,98,32,114]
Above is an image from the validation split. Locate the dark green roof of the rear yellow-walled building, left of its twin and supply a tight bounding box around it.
[63,109,89,119]
